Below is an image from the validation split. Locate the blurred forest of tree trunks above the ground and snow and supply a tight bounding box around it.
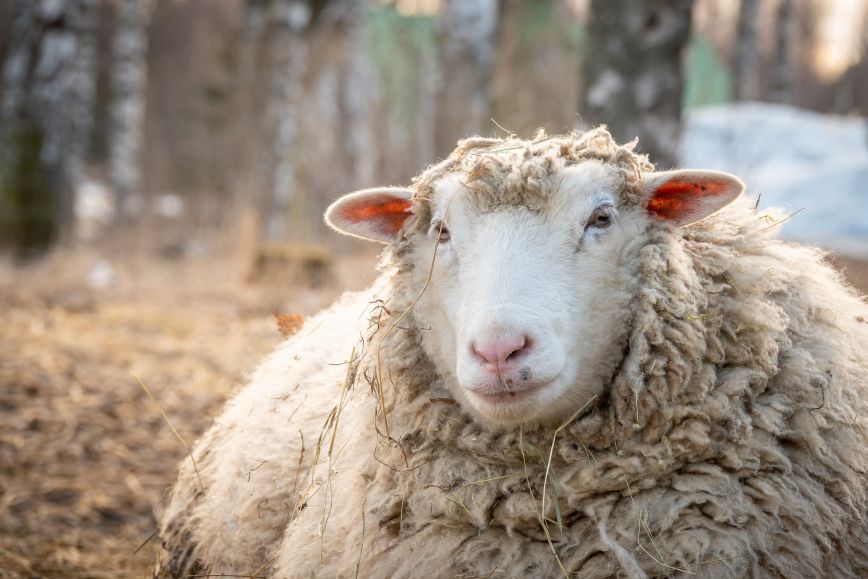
[0,0,868,257]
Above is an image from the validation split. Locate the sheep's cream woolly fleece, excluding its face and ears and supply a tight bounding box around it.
[158,129,868,577]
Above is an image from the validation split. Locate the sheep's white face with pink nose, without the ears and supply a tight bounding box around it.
[413,163,633,423]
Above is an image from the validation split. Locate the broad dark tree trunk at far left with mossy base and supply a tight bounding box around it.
[0,0,97,254]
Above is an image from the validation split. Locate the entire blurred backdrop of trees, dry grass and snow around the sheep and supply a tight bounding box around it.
[0,0,868,579]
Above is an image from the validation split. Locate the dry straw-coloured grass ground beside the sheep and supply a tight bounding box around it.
[0,237,868,578]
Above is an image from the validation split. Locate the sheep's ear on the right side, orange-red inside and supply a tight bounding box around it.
[642,170,744,226]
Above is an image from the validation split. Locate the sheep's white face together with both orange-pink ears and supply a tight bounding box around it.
[327,152,742,425]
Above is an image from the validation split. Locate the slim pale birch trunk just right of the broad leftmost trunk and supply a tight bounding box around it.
[109,0,152,220]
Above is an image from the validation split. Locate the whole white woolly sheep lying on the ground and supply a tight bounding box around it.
[156,127,868,577]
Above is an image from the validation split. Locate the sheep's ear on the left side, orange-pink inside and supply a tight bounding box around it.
[325,187,413,243]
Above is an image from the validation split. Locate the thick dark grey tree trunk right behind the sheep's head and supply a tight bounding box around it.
[582,0,693,168]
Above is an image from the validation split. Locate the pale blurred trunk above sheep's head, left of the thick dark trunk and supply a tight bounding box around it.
[437,0,499,154]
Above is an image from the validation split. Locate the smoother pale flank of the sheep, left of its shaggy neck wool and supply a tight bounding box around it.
[158,293,380,577]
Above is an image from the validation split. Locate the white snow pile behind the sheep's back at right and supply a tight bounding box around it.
[679,103,868,257]
